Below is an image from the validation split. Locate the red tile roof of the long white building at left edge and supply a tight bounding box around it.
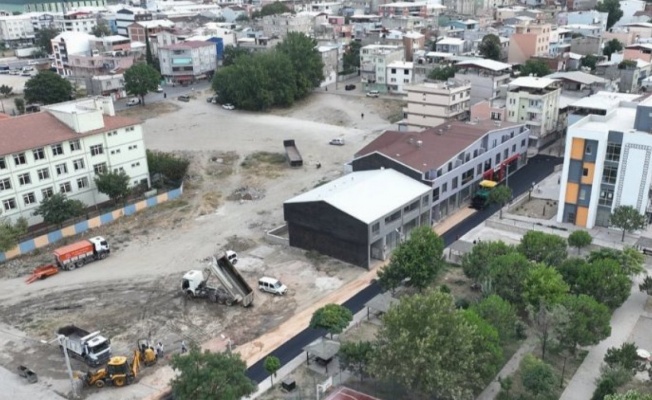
[0,111,141,156]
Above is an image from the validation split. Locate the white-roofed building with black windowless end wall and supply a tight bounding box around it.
[283,169,432,268]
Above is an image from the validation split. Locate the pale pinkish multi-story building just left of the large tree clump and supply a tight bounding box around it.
[158,41,217,84]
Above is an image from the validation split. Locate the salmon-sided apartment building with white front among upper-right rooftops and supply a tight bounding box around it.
[507,24,551,64]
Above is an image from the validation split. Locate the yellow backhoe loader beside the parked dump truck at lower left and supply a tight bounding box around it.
[85,339,157,388]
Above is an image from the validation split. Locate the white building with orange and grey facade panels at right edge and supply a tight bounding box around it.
[557,94,652,229]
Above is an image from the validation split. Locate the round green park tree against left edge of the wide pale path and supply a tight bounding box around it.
[558,294,611,354]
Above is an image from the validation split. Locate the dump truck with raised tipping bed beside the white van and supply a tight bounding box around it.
[181,254,254,307]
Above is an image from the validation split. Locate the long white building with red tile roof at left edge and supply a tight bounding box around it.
[0,97,149,224]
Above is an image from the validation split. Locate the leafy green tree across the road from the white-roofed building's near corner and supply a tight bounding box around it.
[378,225,446,290]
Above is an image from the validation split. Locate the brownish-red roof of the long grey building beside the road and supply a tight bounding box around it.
[355,120,517,172]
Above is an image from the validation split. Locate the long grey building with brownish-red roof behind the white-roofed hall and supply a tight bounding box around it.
[351,120,530,220]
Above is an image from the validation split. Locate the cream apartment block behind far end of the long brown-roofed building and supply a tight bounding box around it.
[505,76,561,148]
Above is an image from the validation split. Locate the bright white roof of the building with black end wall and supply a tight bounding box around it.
[285,169,431,224]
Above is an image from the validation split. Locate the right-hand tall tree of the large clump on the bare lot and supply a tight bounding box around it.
[276,32,324,100]
